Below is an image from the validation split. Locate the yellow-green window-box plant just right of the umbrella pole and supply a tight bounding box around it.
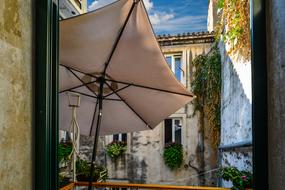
[106,141,127,159]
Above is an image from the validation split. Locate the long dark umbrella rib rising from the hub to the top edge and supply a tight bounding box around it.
[103,0,137,77]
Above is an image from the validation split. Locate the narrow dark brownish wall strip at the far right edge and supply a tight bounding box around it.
[267,0,285,190]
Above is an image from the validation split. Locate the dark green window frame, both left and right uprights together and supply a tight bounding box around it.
[33,0,268,190]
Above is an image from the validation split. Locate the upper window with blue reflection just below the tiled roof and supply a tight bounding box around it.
[166,55,183,81]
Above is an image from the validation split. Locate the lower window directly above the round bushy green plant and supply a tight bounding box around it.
[164,118,182,144]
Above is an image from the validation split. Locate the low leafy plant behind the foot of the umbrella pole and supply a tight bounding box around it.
[76,159,108,182]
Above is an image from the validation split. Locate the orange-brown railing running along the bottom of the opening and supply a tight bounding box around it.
[60,182,229,190]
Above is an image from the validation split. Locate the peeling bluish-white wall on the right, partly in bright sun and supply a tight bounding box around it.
[220,43,252,186]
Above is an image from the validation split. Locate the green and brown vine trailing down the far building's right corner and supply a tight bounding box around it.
[191,46,221,146]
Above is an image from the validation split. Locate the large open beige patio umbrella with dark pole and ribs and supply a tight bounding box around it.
[60,0,193,188]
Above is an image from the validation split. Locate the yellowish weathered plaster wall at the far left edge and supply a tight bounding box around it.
[0,0,32,190]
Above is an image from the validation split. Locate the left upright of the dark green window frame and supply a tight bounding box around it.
[33,0,59,190]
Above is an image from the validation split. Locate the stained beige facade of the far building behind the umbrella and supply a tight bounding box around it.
[80,43,217,186]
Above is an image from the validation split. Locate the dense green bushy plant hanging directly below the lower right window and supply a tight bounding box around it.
[163,143,183,170]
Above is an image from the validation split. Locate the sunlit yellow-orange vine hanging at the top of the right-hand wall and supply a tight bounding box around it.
[216,0,248,59]
